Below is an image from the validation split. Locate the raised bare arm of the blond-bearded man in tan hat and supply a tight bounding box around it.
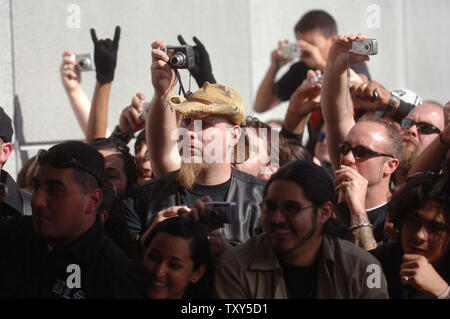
[146,40,181,176]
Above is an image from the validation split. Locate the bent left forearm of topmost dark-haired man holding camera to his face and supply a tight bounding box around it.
[253,42,292,113]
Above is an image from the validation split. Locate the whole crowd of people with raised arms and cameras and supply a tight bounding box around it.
[0,10,450,299]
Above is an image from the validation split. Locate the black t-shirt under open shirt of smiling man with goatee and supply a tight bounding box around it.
[280,260,319,299]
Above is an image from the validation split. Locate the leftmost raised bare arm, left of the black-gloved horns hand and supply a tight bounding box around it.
[59,51,91,135]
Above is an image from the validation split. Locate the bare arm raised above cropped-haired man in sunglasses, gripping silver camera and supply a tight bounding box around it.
[321,34,369,170]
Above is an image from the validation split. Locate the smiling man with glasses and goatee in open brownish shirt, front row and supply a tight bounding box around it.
[214,161,388,299]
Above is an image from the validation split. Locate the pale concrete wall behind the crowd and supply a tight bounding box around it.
[0,0,450,176]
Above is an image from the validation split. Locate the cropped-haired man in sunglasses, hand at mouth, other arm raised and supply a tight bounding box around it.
[321,34,402,249]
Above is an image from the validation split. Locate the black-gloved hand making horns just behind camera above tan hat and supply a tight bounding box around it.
[178,35,216,88]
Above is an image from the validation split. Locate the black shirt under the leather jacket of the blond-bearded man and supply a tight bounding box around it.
[179,178,231,207]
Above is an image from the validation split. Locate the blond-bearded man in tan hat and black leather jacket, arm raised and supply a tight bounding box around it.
[136,41,265,250]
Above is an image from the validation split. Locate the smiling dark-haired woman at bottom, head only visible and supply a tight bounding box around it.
[142,217,211,299]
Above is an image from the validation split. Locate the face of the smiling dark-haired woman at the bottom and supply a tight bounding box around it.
[142,232,202,299]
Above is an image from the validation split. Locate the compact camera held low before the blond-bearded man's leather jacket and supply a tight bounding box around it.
[200,202,237,228]
